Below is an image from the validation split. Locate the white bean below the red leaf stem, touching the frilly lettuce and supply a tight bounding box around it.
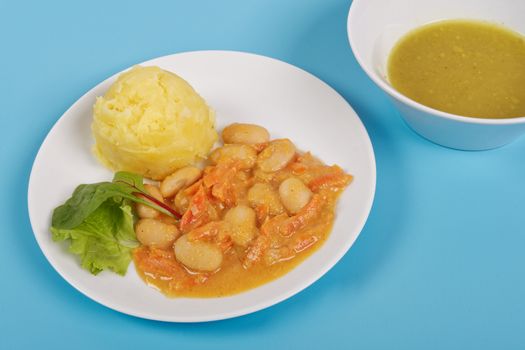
[135,219,179,249]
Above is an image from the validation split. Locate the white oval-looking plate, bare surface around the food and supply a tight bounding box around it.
[28,51,376,322]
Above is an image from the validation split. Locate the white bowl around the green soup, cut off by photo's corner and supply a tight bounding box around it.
[347,0,525,150]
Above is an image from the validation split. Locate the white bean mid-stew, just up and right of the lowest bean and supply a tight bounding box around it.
[224,205,257,247]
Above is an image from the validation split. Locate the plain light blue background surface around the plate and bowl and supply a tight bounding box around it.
[0,0,525,349]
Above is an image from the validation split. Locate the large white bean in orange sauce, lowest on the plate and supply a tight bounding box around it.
[173,235,222,272]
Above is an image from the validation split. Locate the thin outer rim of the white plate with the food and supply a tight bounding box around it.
[27,50,377,323]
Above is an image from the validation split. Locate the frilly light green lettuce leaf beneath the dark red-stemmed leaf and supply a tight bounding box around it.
[51,197,138,275]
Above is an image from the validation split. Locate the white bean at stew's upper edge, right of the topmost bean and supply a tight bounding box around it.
[257,139,295,172]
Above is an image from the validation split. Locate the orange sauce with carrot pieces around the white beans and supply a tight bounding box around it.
[133,148,352,298]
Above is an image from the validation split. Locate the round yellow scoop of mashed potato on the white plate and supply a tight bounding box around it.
[91,66,217,180]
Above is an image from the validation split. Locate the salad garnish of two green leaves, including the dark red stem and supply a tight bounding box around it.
[51,172,180,275]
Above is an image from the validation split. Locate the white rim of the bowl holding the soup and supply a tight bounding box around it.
[346,0,525,125]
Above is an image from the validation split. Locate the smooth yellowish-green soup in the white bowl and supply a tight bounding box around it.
[387,20,525,118]
